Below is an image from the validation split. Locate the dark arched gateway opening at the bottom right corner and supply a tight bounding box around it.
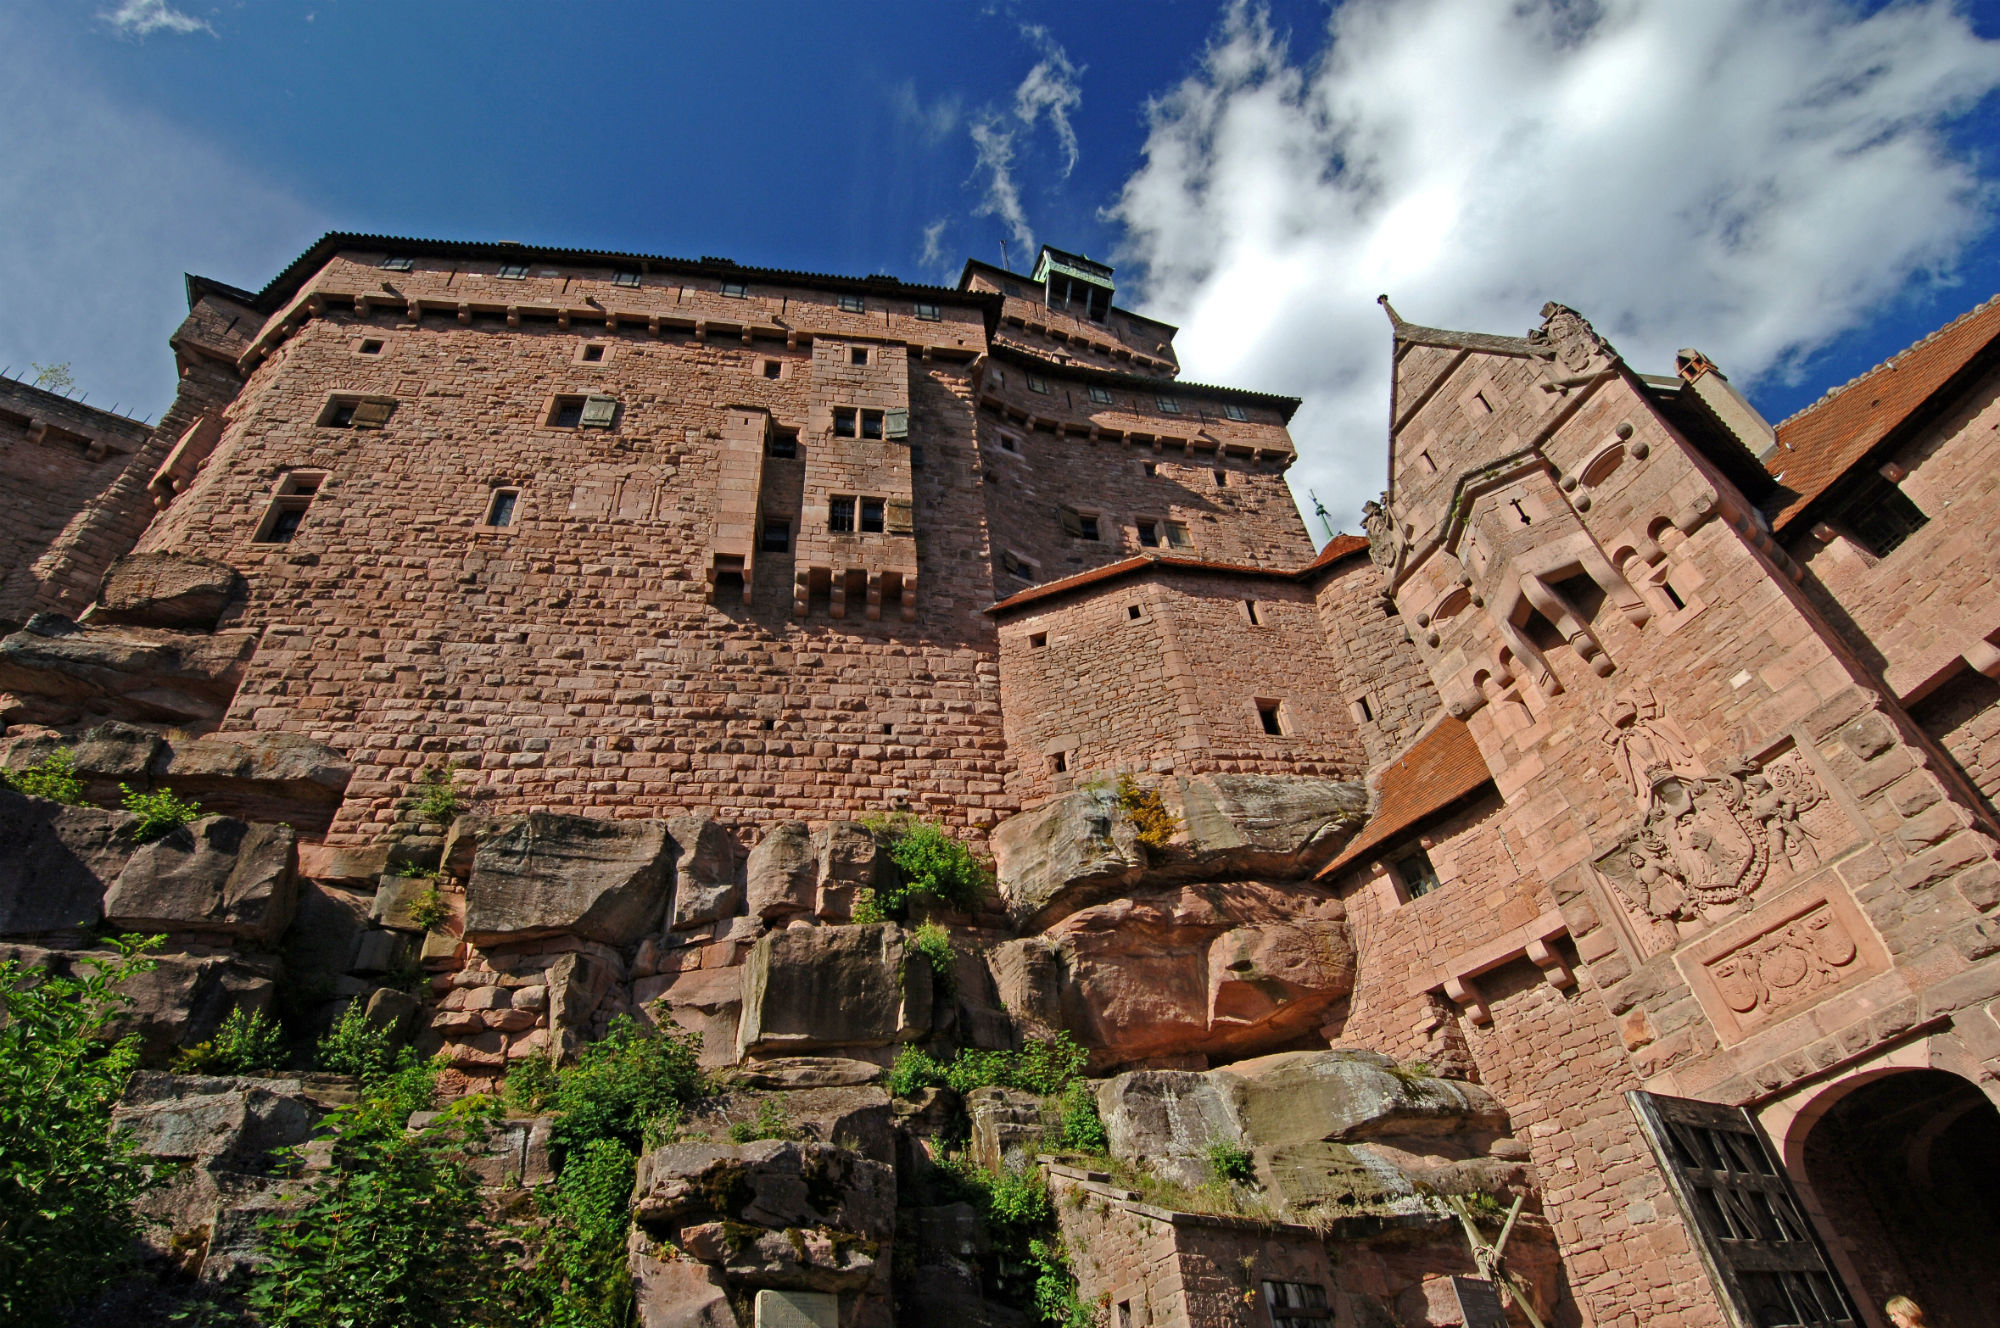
[1784,1068,2000,1328]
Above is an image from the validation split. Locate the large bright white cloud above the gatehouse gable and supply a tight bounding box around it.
[1114,0,2000,532]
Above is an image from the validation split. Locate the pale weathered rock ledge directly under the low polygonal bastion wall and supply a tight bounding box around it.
[992,774,1368,930]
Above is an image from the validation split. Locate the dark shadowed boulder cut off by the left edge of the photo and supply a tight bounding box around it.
[0,788,138,936]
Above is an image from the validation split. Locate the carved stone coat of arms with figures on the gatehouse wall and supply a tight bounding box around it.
[1596,688,1826,956]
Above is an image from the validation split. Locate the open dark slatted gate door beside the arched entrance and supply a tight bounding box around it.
[1626,1090,1860,1328]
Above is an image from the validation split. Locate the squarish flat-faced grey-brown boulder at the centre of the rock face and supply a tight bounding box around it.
[738,922,932,1056]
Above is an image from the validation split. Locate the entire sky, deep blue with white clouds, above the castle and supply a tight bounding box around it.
[0,0,2000,528]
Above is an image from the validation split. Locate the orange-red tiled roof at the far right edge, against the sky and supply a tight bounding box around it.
[1766,296,2000,530]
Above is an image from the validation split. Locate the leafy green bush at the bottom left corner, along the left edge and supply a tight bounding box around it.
[0,938,158,1324]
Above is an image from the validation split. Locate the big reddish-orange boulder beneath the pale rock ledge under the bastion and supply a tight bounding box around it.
[1040,880,1354,1066]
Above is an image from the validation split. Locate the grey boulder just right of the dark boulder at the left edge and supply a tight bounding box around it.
[104,816,298,946]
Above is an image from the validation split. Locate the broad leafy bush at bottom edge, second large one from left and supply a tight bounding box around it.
[248,1066,510,1328]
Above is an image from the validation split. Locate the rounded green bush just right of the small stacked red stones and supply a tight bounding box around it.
[548,1018,708,1154]
